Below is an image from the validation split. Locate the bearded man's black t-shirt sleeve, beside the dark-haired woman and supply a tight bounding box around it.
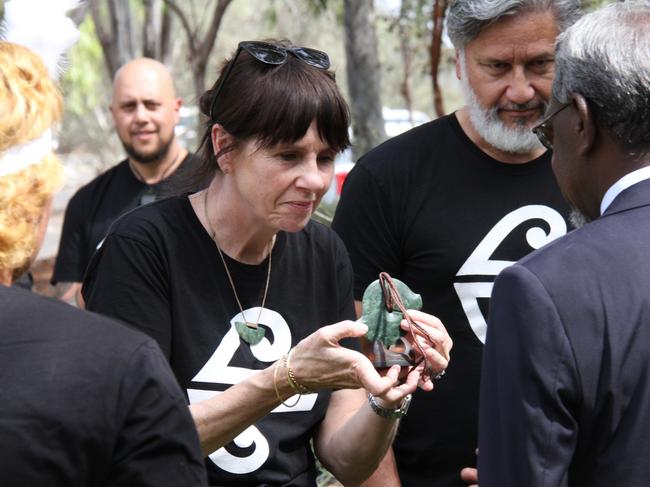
[332,164,402,300]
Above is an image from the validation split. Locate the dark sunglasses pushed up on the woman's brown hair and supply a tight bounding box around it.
[210,41,330,122]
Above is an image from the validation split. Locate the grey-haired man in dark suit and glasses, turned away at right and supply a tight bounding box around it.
[479,0,650,487]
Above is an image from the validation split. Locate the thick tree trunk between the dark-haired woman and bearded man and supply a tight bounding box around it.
[345,0,386,158]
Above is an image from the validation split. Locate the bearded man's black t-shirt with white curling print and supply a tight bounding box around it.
[332,115,568,487]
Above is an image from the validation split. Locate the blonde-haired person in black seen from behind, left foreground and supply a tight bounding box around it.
[0,41,206,487]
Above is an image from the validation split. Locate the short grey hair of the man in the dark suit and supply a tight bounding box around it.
[553,0,650,147]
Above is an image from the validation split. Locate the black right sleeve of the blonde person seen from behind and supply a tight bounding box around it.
[107,341,207,487]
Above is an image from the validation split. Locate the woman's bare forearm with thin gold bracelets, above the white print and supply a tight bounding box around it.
[190,365,293,455]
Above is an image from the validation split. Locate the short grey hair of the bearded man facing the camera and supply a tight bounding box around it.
[447,0,581,50]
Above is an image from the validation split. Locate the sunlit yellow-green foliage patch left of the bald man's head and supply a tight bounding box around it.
[62,16,105,117]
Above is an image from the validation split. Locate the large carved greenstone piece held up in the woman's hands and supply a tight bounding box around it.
[361,279,422,348]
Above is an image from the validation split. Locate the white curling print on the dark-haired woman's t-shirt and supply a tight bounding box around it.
[187,307,318,474]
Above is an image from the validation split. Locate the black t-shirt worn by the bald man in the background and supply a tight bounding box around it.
[52,154,201,284]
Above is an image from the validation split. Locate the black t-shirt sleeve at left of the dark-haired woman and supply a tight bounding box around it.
[82,232,172,359]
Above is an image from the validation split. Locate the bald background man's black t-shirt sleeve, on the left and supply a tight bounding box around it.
[52,193,89,284]
